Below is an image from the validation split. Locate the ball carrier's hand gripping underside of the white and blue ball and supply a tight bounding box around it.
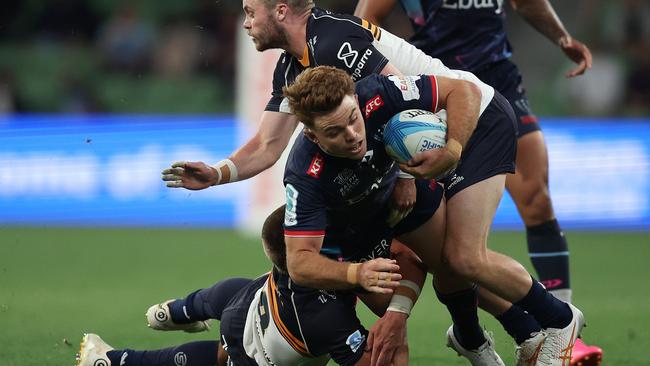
[399,147,458,180]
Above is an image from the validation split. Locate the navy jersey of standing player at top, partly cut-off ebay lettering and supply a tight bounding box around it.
[400,0,512,72]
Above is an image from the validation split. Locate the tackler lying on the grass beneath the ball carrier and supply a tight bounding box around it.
[77,206,426,366]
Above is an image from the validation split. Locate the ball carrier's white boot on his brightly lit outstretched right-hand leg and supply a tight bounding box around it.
[537,304,585,366]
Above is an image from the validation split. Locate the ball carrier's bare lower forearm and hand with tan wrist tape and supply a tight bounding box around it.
[285,235,402,293]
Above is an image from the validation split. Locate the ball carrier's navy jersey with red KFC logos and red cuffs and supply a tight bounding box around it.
[284,75,438,261]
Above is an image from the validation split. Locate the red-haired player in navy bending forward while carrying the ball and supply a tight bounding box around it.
[284,66,584,365]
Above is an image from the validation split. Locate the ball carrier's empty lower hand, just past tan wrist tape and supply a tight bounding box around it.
[358,258,402,294]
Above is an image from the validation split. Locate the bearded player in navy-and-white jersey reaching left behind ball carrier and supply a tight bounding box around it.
[159,0,576,364]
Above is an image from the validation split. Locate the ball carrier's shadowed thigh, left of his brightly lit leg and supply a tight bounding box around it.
[397,199,446,272]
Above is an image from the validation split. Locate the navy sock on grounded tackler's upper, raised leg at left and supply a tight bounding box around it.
[168,278,253,324]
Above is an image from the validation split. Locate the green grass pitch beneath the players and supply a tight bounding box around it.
[0,227,650,366]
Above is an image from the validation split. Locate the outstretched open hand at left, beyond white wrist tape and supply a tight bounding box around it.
[162,161,218,190]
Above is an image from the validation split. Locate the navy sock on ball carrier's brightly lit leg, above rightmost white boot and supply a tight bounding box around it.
[514,278,573,328]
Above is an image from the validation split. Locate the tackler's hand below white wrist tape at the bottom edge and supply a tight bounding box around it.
[367,311,408,366]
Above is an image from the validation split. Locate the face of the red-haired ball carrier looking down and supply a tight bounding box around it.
[310,95,367,160]
